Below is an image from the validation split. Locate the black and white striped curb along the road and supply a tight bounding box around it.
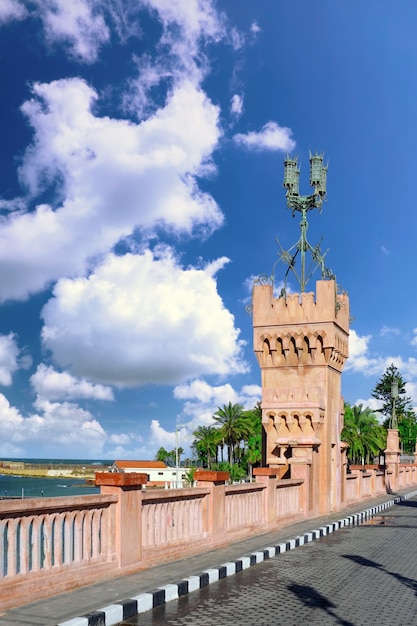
[57,491,417,626]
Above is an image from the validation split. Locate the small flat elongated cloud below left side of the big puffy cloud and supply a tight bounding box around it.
[30,363,114,400]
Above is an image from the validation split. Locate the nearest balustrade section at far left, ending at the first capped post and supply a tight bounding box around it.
[0,495,117,608]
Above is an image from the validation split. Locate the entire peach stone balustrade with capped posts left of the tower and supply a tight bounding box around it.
[0,471,304,610]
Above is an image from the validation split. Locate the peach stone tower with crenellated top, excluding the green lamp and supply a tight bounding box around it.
[252,279,349,514]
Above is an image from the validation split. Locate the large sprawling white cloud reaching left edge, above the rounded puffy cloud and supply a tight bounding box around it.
[0,79,223,300]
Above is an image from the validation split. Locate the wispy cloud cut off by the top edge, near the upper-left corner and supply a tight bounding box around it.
[37,0,110,63]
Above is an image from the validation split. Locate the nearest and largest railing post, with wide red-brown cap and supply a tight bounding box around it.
[96,472,148,568]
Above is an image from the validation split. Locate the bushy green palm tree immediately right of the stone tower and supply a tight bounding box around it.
[340,403,387,464]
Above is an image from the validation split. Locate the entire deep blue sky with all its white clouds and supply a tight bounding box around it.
[0,0,417,459]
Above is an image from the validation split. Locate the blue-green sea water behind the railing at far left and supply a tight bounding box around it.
[0,458,113,499]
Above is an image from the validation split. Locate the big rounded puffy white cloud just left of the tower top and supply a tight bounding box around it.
[42,248,247,386]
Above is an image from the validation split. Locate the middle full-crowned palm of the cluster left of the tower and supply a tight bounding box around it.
[213,402,253,465]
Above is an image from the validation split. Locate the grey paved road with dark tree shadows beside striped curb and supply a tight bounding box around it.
[123,498,417,626]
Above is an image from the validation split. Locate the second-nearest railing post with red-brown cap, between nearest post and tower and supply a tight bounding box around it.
[195,470,229,542]
